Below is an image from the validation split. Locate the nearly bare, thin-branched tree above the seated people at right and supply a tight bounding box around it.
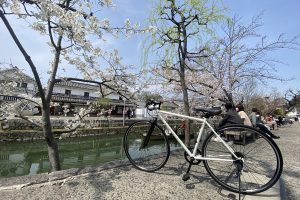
[199,15,299,103]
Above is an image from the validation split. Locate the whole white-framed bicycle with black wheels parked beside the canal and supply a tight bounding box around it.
[123,101,283,194]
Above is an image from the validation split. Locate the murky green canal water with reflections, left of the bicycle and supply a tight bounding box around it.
[0,135,178,177]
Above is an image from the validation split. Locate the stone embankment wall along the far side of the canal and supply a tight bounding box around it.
[0,117,139,142]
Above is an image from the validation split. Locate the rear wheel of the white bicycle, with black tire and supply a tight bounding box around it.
[202,125,283,194]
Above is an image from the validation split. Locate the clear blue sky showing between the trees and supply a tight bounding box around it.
[0,0,300,93]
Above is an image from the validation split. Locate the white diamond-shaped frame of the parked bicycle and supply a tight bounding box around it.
[156,110,241,162]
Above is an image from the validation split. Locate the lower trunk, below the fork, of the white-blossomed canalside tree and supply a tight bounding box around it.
[42,104,61,171]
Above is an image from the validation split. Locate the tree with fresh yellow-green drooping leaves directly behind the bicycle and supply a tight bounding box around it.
[146,0,223,145]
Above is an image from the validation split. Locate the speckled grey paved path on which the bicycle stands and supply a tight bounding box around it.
[0,123,300,200]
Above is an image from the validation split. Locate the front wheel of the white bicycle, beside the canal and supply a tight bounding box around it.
[123,121,170,172]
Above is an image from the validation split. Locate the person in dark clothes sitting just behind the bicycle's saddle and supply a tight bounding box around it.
[219,102,243,127]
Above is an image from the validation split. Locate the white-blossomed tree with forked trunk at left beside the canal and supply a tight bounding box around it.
[0,0,153,171]
